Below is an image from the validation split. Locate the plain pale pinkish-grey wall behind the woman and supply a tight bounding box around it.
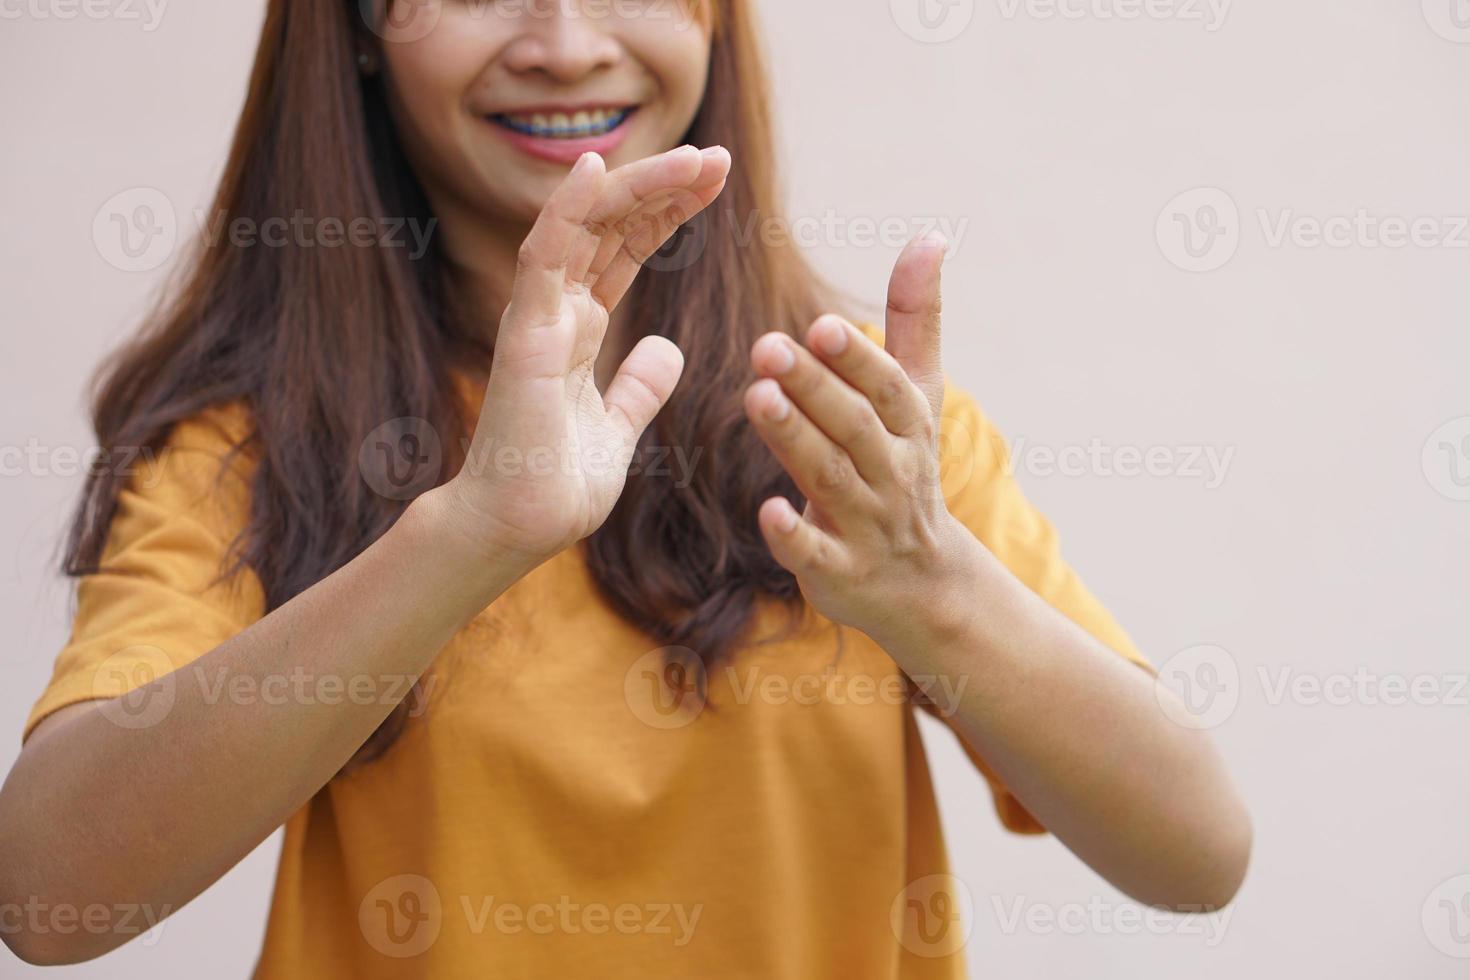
[0,0,1470,979]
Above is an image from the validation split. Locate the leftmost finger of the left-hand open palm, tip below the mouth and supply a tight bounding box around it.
[510,153,607,322]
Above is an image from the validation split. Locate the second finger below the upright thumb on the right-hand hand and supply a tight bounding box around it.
[750,334,887,486]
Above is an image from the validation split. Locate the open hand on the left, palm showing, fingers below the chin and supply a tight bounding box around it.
[447,145,731,564]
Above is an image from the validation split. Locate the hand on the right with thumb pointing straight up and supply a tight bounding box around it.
[745,230,969,638]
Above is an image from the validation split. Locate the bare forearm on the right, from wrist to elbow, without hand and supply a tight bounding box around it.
[889,538,1251,911]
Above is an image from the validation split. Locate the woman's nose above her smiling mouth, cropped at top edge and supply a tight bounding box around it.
[503,0,623,82]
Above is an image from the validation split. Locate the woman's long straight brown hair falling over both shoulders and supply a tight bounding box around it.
[65,0,823,761]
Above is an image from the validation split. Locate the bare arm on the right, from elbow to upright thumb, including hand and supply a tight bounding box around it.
[745,241,1251,911]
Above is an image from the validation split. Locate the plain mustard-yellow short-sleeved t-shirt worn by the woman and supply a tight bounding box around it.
[26,362,1144,980]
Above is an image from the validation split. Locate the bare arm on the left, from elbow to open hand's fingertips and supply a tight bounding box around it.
[0,147,731,964]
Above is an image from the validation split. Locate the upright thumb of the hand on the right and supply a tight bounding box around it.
[885,232,948,419]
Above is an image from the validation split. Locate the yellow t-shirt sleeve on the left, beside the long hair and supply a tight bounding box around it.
[22,406,265,739]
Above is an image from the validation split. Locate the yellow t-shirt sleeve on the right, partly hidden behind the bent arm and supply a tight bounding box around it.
[935,383,1151,833]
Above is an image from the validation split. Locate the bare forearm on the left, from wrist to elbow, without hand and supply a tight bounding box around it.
[0,495,519,959]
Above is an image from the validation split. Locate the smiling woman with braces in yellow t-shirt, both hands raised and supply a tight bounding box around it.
[0,0,1250,977]
